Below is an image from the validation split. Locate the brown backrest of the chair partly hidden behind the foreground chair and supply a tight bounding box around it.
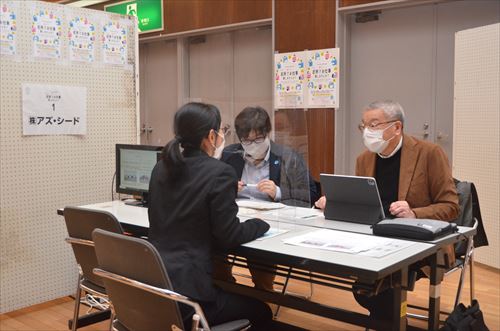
[64,207,123,287]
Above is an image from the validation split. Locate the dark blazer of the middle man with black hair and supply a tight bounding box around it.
[221,141,319,207]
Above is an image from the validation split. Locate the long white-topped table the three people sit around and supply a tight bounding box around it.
[60,201,473,330]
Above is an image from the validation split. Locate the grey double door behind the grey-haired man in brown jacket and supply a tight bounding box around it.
[335,0,500,173]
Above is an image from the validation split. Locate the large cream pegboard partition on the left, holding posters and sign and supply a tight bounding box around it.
[0,1,138,313]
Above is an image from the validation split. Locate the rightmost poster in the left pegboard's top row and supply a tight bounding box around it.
[102,21,128,65]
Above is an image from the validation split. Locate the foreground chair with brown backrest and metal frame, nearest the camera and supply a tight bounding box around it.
[93,229,250,331]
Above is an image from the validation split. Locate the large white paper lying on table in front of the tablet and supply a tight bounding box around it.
[284,229,415,257]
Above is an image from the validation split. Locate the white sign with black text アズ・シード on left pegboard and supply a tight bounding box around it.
[22,84,87,135]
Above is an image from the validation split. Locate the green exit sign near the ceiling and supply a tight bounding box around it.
[104,0,163,33]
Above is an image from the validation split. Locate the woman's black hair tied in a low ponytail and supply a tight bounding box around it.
[162,102,221,180]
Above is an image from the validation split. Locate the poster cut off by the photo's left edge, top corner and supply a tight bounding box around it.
[0,1,19,55]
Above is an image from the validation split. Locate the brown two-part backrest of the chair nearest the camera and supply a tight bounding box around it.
[93,229,184,331]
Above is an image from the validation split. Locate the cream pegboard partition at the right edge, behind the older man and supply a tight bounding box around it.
[453,24,500,268]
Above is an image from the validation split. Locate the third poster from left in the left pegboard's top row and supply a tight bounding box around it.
[68,16,96,63]
